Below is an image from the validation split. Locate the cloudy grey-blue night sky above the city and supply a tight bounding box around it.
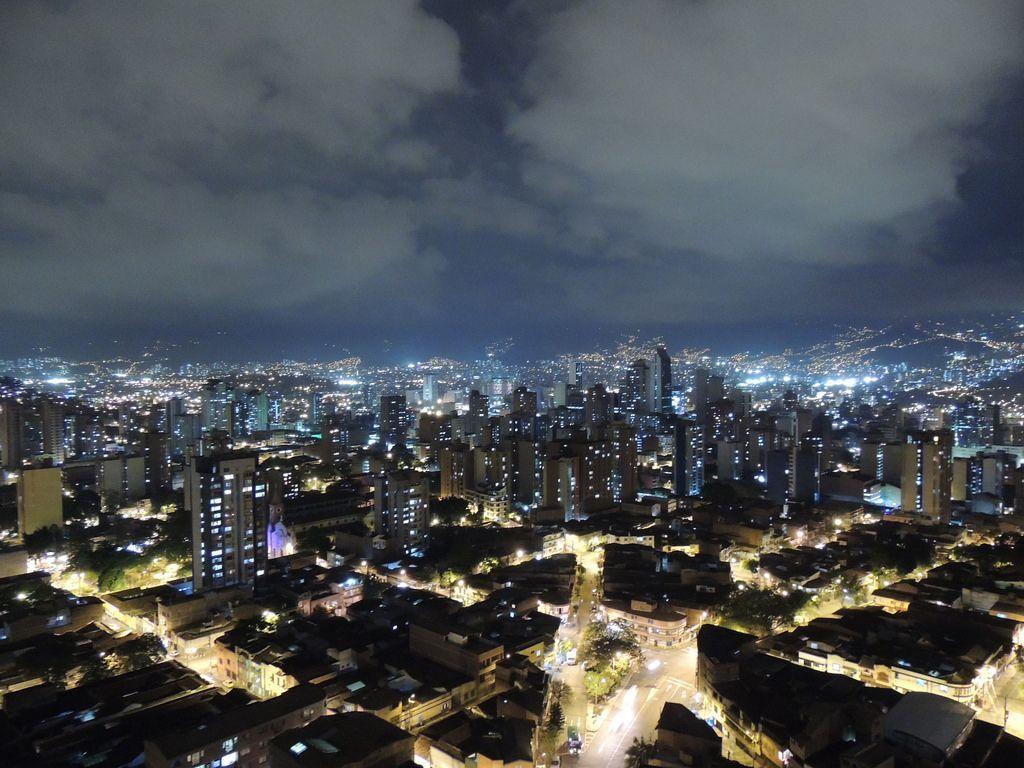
[0,0,1024,357]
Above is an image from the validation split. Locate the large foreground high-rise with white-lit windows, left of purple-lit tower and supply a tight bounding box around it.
[184,452,266,591]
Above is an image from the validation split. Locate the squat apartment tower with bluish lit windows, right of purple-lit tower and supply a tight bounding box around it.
[374,469,430,555]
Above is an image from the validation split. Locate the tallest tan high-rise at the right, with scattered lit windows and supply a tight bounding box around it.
[900,429,953,524]
